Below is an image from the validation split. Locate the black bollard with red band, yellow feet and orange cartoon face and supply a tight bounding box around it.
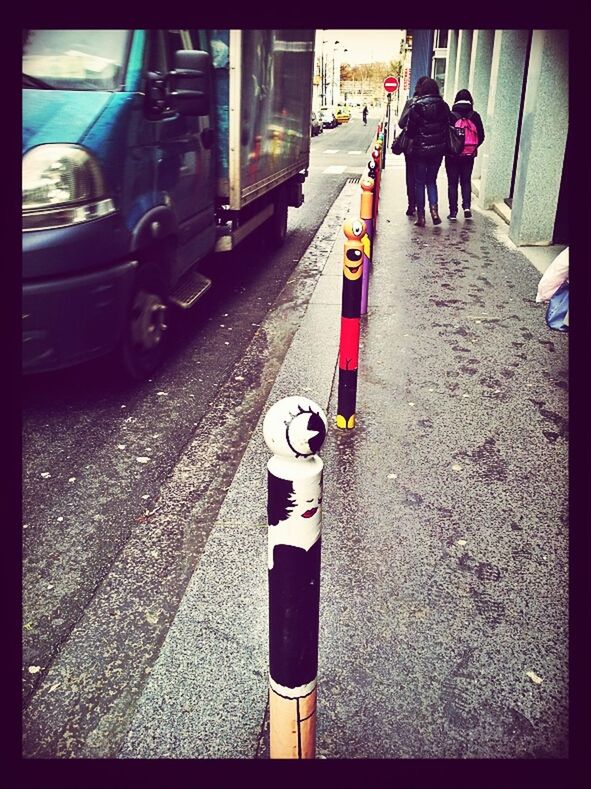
[337,219,366,429]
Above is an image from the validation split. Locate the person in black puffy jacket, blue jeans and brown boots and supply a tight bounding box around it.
[406,78,452,227]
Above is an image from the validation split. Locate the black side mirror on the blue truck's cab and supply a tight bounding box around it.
[168,49,211,116]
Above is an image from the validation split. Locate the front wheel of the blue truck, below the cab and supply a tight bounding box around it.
[118,263,168,381]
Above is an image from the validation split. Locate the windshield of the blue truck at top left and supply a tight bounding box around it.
[23,30,130,90]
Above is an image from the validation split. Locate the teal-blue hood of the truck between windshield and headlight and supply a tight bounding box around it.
[22,88,113,153]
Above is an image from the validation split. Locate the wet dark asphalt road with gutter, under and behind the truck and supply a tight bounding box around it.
[23,118,375,757]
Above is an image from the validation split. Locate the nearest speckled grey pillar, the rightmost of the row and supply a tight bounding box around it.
[509,30,569,246]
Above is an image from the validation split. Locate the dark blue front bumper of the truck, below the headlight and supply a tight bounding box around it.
[22,255,137,373]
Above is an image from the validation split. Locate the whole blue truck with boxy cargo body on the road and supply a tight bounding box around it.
[22,30,314,380]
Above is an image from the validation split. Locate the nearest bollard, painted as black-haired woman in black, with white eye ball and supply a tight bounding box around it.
[263,397,328,759]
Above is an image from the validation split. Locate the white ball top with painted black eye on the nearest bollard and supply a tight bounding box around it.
[263,395,328,458]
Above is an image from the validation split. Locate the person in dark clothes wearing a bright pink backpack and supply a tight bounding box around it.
[445,90,484,220]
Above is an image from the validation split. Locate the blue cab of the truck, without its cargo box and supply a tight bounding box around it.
[22,30,215,378]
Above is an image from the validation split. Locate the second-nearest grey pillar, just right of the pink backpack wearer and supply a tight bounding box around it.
[478,30,529,209]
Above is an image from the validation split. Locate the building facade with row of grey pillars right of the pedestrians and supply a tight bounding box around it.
[431,30,569,246]
